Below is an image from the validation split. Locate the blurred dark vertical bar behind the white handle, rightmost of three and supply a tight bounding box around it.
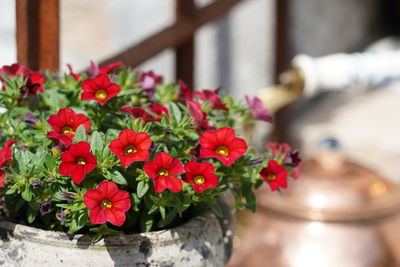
[272,0,292,142]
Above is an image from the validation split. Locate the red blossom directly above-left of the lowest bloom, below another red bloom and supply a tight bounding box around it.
[60,142,97,184]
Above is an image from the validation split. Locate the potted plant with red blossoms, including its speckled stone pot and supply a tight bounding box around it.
[0,62,299,266]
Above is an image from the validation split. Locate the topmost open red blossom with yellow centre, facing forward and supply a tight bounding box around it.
[81,73,121,105]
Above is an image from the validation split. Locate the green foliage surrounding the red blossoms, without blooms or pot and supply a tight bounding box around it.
[0,63,296,240]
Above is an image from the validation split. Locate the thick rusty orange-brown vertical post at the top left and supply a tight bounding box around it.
[16,0,60,71]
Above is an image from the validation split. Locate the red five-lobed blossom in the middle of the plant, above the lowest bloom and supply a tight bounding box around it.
[108,129,151,167]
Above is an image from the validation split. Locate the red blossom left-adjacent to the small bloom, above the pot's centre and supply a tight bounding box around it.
[143,152,183,193]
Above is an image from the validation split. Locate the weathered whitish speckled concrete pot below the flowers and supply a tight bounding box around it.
[0,213,232,267]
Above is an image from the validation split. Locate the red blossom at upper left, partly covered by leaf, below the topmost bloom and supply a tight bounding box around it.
[47,108,90,137]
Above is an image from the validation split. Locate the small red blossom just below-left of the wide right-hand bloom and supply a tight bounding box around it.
[183,161,218,193]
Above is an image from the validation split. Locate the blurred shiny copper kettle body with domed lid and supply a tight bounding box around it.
[229,151,400,267]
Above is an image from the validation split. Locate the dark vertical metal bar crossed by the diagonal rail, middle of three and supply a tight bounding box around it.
[175,0,196,88]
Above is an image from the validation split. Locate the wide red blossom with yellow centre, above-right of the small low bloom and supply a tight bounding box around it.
[200,127,247,166]
